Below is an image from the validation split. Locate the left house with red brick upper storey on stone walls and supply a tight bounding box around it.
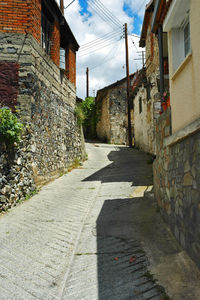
[0,0,85,210]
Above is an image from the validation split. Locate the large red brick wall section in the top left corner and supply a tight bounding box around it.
[0,0,41,42]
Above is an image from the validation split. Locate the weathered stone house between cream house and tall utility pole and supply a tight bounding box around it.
[132,0,168,154]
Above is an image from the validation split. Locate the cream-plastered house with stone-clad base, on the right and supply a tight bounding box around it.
[152,0,200,267]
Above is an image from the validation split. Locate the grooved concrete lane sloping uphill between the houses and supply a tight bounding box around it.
[0,144,200,300]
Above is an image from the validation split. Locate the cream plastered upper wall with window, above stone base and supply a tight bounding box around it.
[163,0,200,133]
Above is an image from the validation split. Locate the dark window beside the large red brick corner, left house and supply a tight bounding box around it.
[41,12,53,54]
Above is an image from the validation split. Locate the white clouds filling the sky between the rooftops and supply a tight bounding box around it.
[57,0,148,98]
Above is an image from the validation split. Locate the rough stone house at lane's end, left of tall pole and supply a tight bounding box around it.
[95,74,135,144]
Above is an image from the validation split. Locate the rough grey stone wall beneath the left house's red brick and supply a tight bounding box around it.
[0,33,84,210]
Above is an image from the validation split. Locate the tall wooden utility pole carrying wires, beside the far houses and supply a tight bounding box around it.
[125,23,132,148]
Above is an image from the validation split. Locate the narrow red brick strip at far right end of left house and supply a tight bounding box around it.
[66,48,76,86]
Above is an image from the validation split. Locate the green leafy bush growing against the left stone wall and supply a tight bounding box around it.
[0,107,23,146]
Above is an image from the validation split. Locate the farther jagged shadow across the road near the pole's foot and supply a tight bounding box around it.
[83,147,153,186]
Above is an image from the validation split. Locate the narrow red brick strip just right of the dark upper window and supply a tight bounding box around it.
[51,21,60,67]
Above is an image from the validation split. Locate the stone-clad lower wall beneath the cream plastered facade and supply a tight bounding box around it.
[153,109,200,267]
